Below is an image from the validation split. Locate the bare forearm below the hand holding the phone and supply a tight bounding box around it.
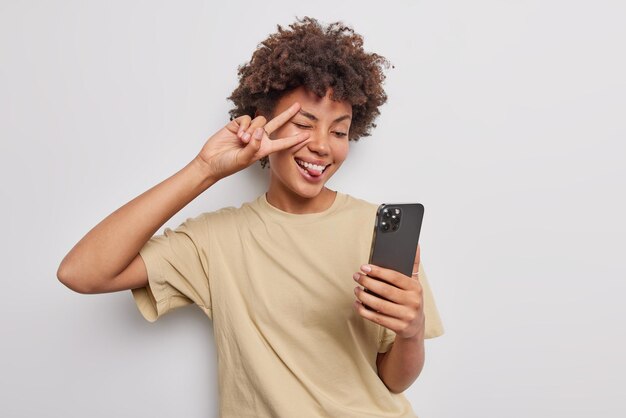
[378,334,425,393]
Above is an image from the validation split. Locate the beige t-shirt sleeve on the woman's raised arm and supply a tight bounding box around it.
[132,215,212,322]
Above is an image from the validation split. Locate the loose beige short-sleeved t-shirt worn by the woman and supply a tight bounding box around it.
[132,192,443,418]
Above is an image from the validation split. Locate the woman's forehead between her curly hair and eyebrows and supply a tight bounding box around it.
[274,86,352,119]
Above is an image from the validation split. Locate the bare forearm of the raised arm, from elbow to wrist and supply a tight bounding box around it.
[57,158,216,287]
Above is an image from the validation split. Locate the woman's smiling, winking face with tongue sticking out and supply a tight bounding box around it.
[269,87,352,198]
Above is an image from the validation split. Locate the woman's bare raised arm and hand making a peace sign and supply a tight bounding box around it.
[57,103,309,293]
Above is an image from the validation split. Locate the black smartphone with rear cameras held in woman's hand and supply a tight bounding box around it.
[363,203,424,311]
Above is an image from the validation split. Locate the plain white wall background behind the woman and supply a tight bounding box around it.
[0,0,626,418]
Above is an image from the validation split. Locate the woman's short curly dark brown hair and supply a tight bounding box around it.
[228,17,390,168]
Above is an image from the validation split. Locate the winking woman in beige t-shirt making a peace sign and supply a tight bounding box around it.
[58,18,443,418]
